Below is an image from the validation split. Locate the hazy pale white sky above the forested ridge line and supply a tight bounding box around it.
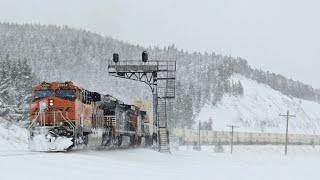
[0,0,320,88]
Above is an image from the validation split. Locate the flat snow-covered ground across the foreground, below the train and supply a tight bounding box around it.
[0,145,320,180]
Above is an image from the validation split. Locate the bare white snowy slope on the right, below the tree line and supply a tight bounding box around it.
[196,75,320,134]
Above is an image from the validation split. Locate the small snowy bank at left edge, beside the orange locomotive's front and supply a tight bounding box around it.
[0,117,28,151]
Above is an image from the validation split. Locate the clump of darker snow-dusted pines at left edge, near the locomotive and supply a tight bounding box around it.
[0,54,38,121]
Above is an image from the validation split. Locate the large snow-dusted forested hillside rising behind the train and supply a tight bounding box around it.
[0,23,320,131]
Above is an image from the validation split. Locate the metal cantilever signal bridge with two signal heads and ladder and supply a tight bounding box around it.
[108,51,176,152]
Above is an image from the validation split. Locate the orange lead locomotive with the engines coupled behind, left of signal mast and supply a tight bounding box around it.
[29,82,152,151]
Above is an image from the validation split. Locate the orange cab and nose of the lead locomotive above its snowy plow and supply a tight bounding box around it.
[30,82,78,127]
